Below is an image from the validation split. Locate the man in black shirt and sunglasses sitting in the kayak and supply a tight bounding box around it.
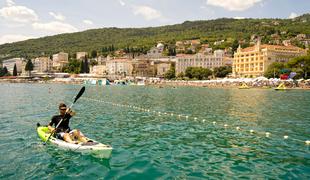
[48,103,87,144]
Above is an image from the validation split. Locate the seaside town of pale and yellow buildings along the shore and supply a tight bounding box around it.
[1,34,310,86]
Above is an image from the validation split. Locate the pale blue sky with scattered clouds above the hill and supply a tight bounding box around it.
[0,0,310,44]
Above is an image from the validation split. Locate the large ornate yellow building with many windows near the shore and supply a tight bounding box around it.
[233,41,306,77]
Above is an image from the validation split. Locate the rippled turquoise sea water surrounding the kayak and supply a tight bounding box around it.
[0,84,310,179]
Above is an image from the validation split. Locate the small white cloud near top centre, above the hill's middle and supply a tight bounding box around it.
[133,6,163,20]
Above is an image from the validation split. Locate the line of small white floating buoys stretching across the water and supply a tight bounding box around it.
[81,97,310,146]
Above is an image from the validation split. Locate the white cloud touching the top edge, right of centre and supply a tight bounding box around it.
[207,0,263,11]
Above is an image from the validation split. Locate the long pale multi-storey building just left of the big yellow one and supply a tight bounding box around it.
[176,50,224,74]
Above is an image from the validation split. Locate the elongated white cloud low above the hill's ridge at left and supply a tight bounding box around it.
[32,21,78,33]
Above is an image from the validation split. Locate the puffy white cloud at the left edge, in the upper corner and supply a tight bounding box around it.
[0,2,39,23]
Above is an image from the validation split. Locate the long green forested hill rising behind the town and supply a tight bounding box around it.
[0,14,310,59]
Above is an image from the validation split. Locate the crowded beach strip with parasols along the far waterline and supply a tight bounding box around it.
[0,77,310,90]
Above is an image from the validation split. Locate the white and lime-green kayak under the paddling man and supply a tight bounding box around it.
[37,125,113,158]
